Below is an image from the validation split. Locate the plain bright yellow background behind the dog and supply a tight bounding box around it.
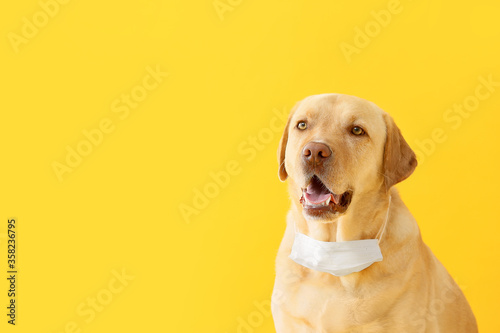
[0,0,500,333]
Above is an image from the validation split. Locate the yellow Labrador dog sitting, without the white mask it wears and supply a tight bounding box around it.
[272,94,477,333]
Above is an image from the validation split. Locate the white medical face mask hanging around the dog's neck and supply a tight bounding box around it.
[289,197,391,276]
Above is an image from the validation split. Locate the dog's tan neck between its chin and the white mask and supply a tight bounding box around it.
[294,190,398,242]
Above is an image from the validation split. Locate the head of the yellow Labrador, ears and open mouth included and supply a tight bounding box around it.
[278,94,417,221]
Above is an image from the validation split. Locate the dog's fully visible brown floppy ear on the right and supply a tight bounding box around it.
[383,114,417,191]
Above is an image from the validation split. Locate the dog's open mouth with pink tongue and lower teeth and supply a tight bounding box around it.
[300,175,352,216]
